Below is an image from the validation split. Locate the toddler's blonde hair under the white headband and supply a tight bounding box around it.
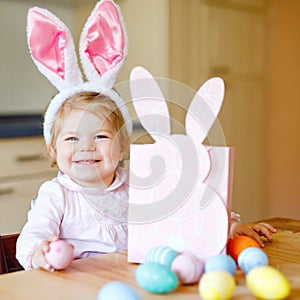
[47,92,129,166]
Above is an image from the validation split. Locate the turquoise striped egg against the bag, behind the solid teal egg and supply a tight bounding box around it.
[145,246,178,268]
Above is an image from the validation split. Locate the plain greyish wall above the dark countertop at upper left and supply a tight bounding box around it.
[0,1,75,115]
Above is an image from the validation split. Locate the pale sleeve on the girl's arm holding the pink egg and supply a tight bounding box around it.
[16,181,65,270]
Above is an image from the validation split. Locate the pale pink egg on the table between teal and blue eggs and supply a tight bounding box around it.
[171,251,204,284]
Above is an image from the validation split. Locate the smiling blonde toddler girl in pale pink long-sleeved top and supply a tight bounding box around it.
[17,92,128,270]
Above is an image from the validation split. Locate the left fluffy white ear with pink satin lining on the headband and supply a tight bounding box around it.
[27,7,82,90]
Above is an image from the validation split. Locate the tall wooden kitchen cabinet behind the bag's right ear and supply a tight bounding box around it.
[169,0,268,221]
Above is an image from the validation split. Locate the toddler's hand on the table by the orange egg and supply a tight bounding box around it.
[230,222,276,247]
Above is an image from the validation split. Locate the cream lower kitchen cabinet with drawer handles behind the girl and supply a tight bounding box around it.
[0,137,57,234]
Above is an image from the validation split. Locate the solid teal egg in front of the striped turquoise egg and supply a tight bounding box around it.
[135,262,178,294]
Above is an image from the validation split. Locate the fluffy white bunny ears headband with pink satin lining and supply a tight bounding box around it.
[27,0,132,144]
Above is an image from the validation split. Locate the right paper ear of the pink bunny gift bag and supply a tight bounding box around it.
[185,78,224,142]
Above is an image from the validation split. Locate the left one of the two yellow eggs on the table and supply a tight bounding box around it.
[199,271,235,300]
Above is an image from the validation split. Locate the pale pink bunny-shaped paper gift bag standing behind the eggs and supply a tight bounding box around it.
[128,67,233,263]
